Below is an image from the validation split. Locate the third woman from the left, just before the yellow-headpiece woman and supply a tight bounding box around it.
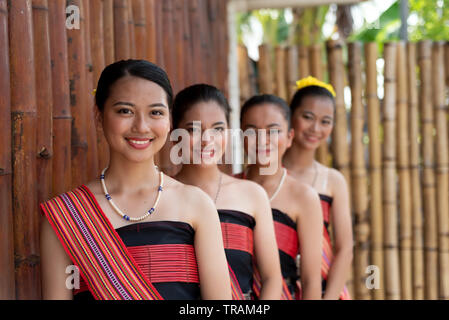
[240,95,323,300]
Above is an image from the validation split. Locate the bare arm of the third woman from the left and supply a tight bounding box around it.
[296,185,323,300]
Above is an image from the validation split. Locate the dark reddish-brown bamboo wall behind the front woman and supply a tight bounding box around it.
[0,0,228,299]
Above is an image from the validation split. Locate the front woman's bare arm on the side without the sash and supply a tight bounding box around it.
[189,189,232,300]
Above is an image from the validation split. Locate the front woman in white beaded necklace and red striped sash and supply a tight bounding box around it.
[41,60,231,299]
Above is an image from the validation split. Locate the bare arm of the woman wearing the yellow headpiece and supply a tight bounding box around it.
[323,170,353,300]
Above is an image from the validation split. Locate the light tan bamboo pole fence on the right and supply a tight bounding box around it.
[239,41,449,300]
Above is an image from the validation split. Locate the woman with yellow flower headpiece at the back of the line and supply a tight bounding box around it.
[283,77,353,299]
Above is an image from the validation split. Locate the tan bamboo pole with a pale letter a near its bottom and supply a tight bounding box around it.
[365,42,385,300]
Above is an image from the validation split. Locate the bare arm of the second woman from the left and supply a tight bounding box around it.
[253,183,282,300]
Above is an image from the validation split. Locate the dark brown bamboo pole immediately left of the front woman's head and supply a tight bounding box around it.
[80,1,99,180]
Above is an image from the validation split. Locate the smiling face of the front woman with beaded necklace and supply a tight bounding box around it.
[100,76,170,162]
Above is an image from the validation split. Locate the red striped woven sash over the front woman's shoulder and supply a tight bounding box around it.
[41,186,162,300]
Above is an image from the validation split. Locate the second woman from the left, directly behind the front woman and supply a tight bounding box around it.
[172,84,282,299]
